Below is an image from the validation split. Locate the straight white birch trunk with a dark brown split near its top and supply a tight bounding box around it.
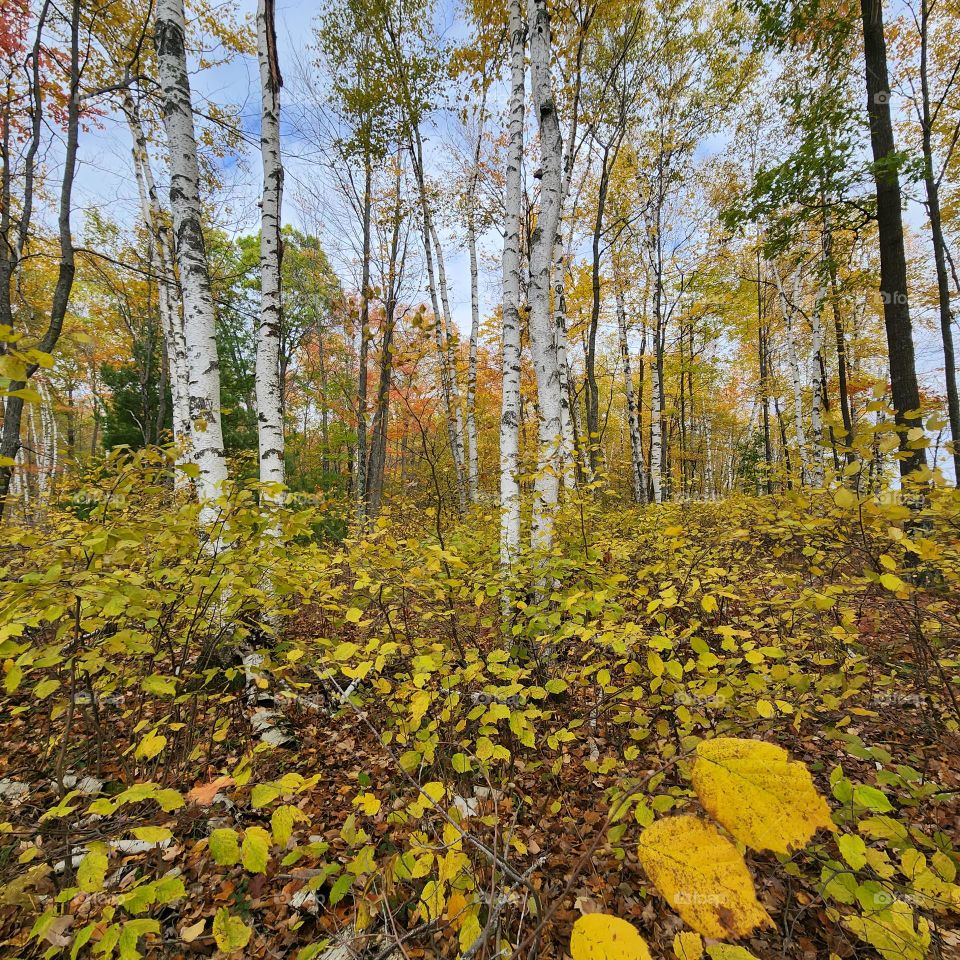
[256,0,285,499]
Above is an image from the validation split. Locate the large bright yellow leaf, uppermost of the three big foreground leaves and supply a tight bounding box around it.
[693,737,835,853]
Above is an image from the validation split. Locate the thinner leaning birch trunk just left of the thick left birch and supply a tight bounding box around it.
[123,90,190,490]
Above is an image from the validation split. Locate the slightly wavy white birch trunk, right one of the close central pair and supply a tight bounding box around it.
[527,0,563,550]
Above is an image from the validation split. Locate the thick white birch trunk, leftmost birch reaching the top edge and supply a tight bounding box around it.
[155,0,227,521]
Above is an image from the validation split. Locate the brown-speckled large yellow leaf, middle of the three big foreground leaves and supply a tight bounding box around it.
[637,816,772,940]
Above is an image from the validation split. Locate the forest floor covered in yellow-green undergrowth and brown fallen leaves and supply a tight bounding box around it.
[0,480,960,960]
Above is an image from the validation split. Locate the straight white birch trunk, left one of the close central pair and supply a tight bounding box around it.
[500,0,527,569]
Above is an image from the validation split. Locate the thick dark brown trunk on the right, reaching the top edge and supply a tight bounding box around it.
[860,0,927,477]
